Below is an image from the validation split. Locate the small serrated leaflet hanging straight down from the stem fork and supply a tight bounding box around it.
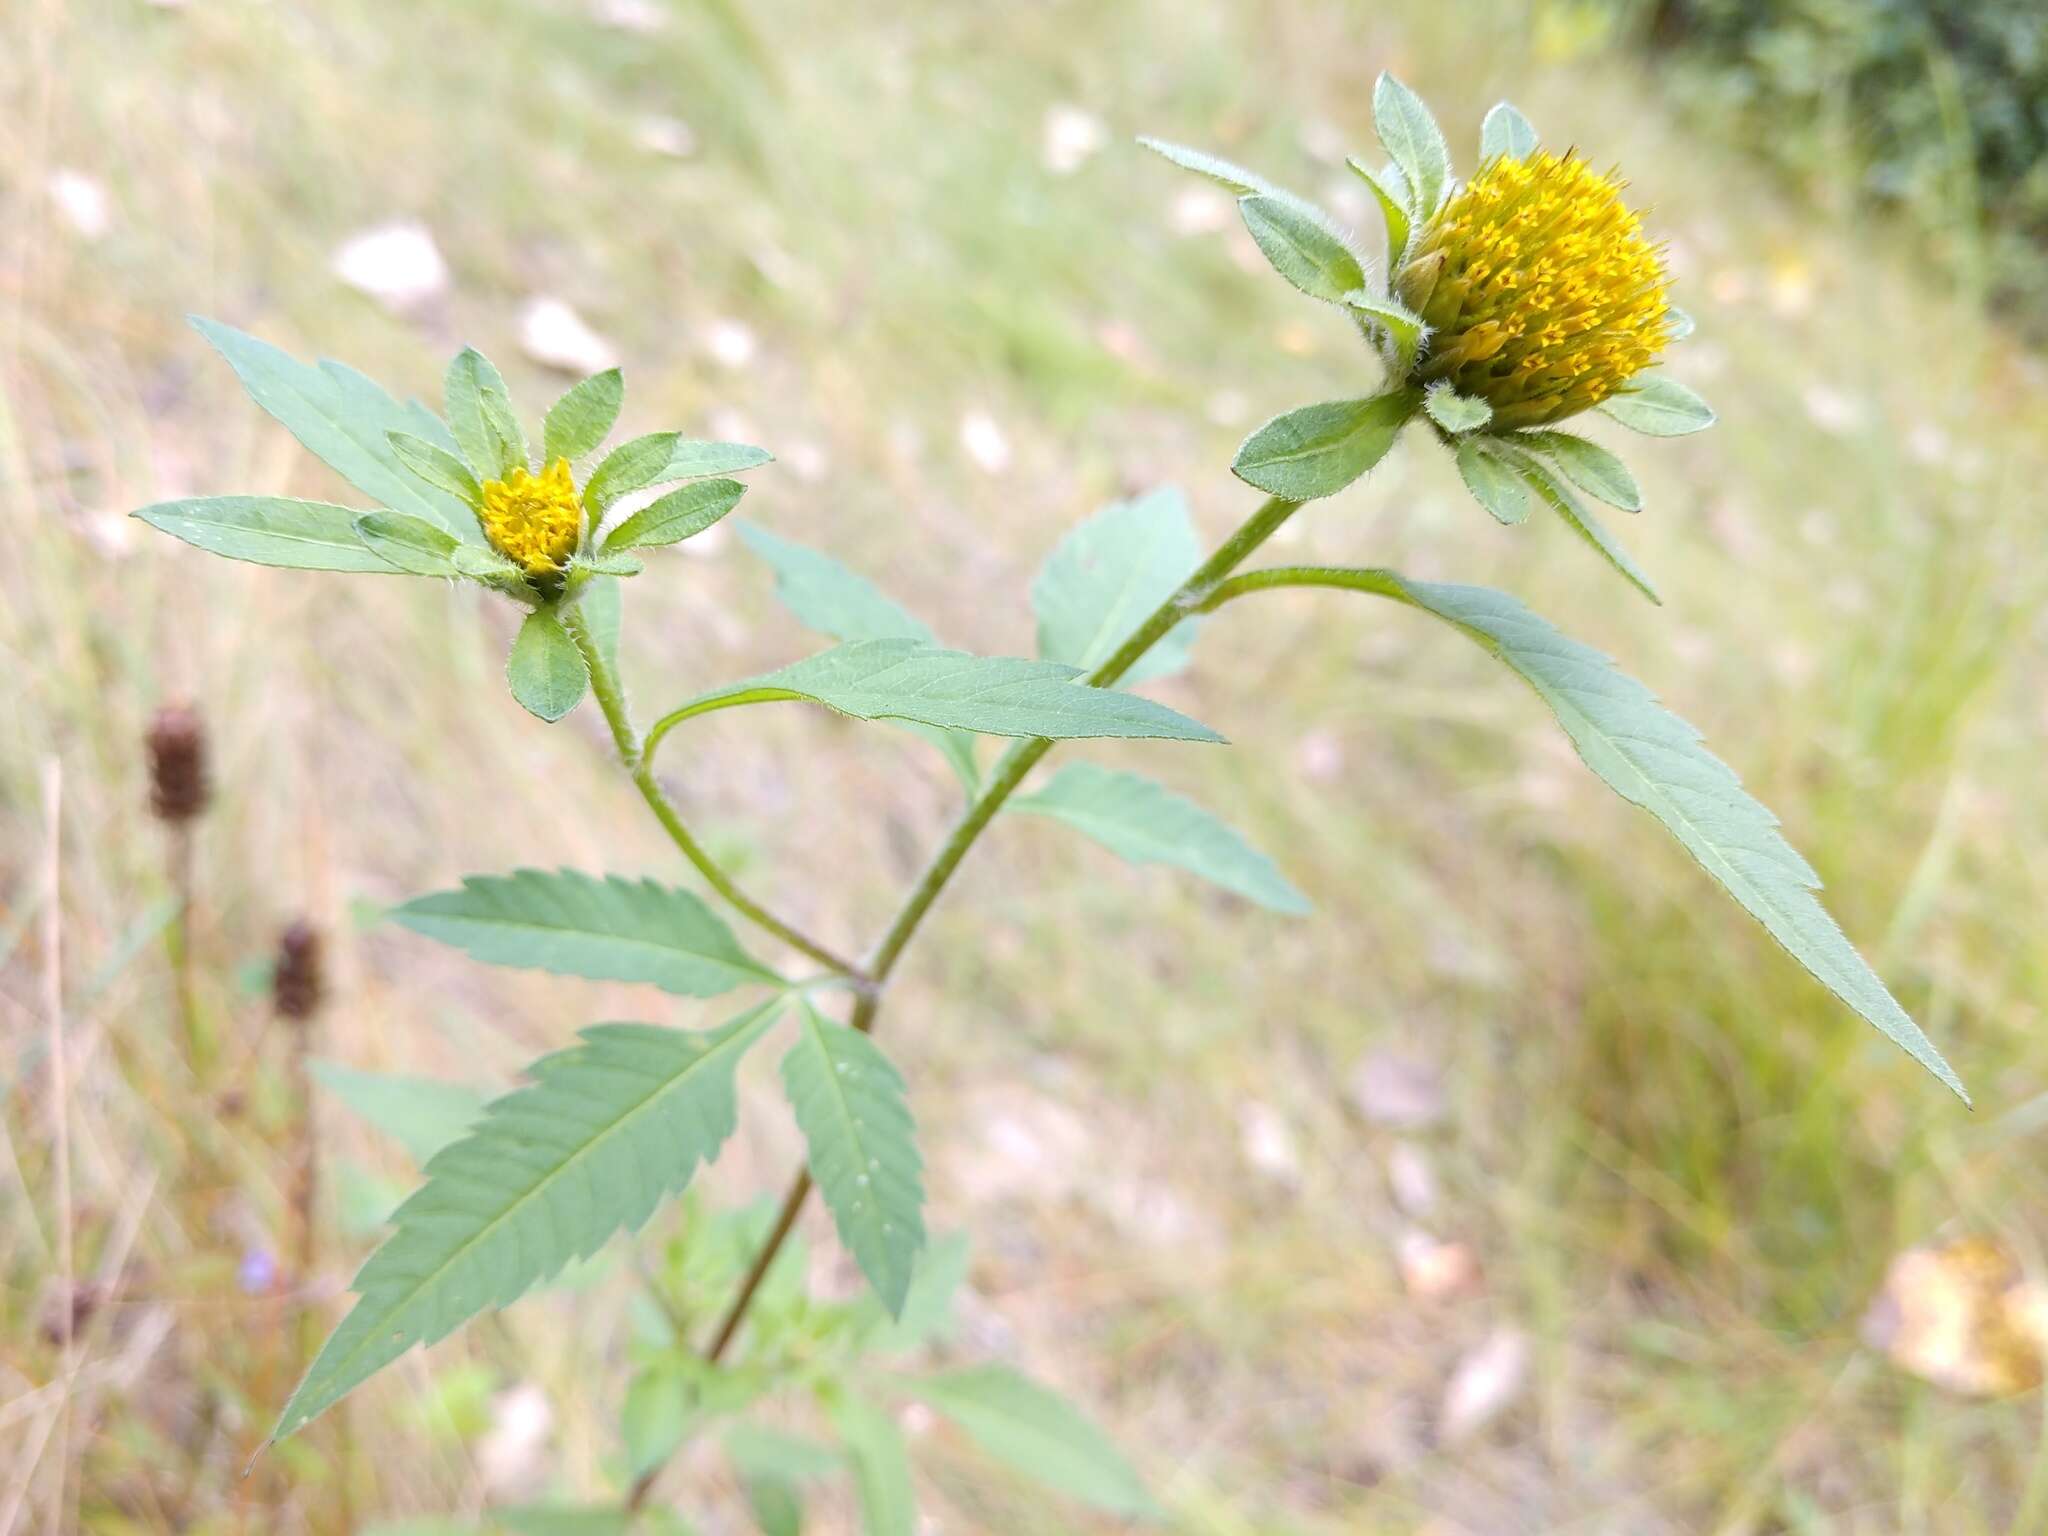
[782,1001,924,1317]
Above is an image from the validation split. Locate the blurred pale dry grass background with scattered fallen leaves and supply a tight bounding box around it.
[0,0,2048,1536]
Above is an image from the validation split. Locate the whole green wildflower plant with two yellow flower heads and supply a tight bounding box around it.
[137,76,1962,1532]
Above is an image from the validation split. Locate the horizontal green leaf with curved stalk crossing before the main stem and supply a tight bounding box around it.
[649,639,1223,750]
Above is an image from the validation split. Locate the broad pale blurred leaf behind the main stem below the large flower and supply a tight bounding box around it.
[1030,485,1202,684]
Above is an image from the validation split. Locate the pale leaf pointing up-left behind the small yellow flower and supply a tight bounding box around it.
[180,315,483,544]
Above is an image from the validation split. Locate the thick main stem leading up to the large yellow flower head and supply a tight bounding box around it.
[622,496,1300,1511]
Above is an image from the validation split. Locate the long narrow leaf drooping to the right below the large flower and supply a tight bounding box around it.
[1294,571,1970,1104]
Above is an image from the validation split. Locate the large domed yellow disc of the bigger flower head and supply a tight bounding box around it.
[1397,150,1671,428]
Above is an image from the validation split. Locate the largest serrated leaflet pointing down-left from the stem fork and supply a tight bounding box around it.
[272,999,782,1438]
